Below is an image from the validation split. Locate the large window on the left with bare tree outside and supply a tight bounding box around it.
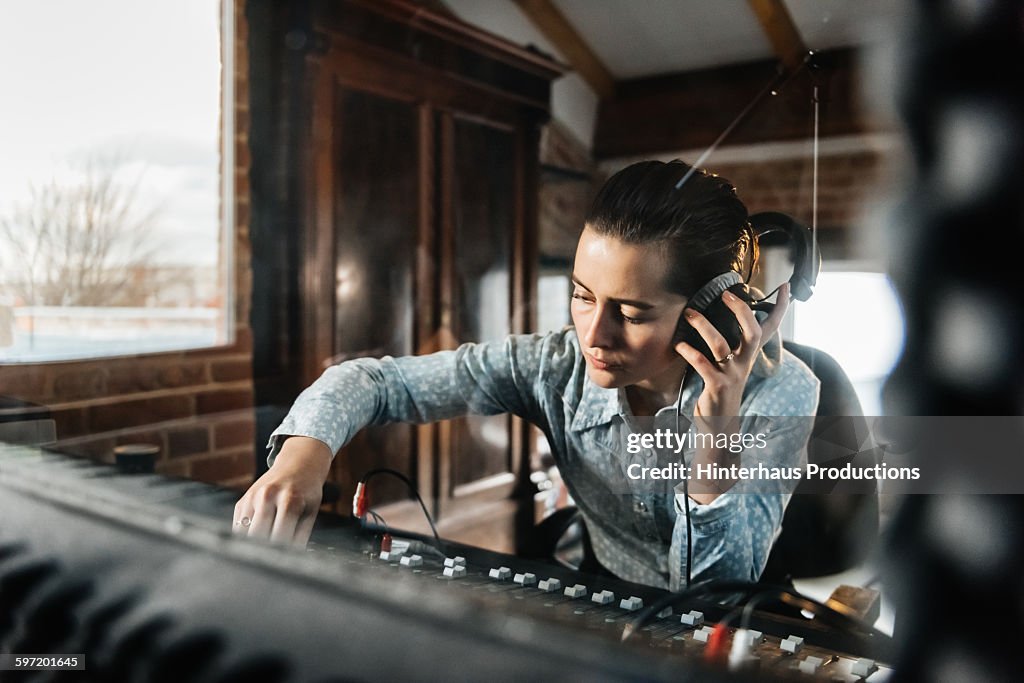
[0,0,233,362]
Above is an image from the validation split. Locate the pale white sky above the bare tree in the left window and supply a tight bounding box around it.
[0,0,220,264]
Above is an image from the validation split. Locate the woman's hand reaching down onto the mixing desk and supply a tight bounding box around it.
[232,436,332,546]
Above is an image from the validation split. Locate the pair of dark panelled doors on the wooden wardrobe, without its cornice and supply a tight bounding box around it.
[303,46,537,550]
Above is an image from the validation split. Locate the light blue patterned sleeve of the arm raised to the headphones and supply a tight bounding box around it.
[669,360,818,590]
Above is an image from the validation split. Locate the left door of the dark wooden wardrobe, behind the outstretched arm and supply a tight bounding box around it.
[305,82,429,509]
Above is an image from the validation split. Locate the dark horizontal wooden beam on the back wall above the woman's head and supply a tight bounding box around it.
[594,49,886,161]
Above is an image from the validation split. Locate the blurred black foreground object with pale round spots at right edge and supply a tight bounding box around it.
[886,1,1024,681]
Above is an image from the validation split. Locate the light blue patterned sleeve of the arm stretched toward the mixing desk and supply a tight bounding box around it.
[267,335,563,465]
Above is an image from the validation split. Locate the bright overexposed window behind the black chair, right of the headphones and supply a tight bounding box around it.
[792,266,903,416]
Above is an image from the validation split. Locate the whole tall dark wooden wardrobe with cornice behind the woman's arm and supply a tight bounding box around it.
[266,0,561,551]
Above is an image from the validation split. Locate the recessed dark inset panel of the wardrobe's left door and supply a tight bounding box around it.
[329,88,420,503]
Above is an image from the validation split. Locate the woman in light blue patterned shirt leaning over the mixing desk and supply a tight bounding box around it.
[234,161,817,589]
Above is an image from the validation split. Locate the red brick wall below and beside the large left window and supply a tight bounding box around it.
[0,0,255,486]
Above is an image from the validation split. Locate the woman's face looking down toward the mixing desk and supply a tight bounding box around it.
[570,227,686,391]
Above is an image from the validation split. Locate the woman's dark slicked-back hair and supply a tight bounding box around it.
[587,159,757,298]
